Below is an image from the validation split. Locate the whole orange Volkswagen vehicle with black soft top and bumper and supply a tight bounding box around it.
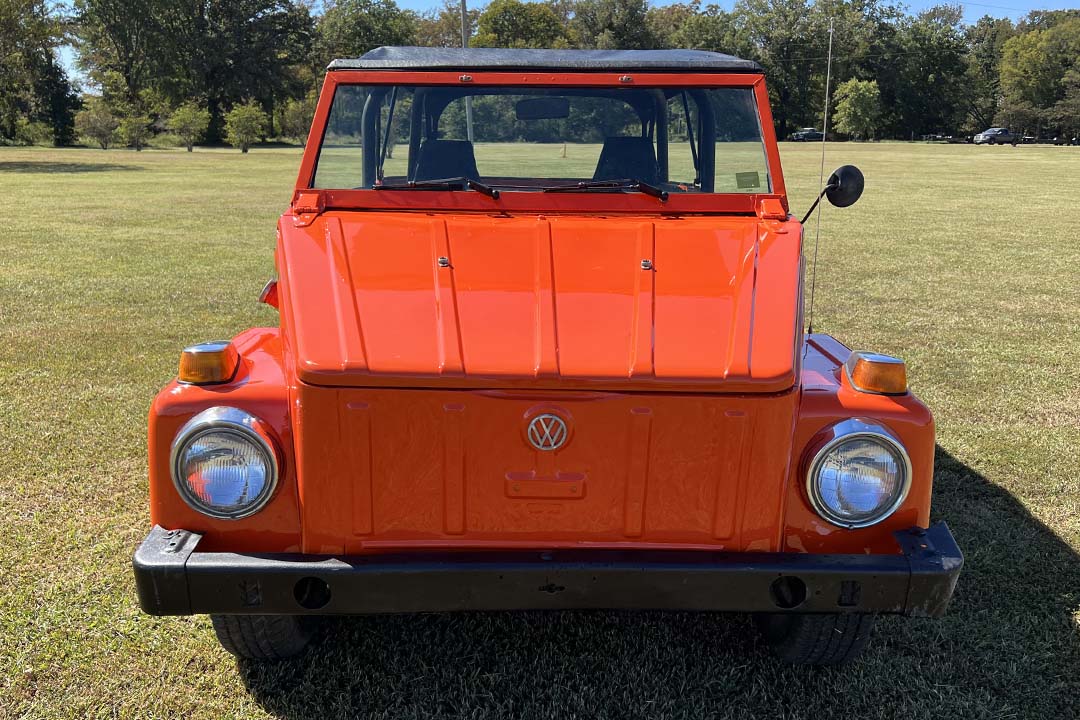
[134,47,963,663]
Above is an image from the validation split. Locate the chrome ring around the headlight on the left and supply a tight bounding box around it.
[168,406,281,520]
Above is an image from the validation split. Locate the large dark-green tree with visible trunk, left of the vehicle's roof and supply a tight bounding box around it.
[75,0,314,139]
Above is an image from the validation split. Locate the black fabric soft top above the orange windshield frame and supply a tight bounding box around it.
[327,47,761,72]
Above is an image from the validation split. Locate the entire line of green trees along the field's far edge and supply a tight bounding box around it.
[0,0,1080,151]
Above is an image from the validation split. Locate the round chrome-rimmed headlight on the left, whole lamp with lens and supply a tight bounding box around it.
[172,407,278,519]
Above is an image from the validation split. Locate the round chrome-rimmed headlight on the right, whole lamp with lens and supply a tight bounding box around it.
[807,419,912,528]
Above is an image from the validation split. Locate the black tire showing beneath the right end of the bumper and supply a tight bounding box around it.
[755,613,876,665]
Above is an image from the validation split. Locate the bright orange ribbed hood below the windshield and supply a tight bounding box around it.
[278,212,801,392]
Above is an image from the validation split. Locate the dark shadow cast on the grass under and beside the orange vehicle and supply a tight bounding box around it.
[239,448,1080,718]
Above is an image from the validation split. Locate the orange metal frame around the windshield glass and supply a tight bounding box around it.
[294,70,788,214]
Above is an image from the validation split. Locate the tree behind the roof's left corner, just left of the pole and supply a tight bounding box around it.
[315,0,416,68]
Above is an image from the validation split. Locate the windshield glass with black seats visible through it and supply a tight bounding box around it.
[312,85,772,194]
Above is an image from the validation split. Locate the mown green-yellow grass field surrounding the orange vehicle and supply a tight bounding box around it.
[0,138,1080,720]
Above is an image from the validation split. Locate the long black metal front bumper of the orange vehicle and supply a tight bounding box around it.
[134,522,963,616]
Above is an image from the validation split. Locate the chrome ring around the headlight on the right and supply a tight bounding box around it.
[806,418,912,530]
